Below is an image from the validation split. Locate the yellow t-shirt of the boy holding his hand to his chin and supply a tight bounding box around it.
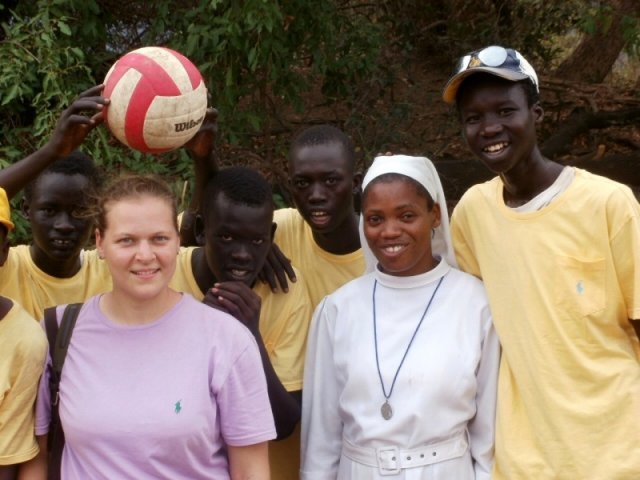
[170,247,312,480]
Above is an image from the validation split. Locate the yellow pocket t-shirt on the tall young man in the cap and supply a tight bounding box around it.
[451,169,640,480]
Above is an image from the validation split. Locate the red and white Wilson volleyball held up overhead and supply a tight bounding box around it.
[103,47,207,153]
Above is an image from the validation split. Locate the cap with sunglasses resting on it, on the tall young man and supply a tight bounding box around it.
[442,45,539,103]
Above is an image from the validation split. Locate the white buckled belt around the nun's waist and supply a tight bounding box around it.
[342,431,469,475]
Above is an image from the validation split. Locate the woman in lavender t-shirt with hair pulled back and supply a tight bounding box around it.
[31,176,276,480]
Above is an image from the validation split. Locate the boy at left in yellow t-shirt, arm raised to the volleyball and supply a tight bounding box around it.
[0,86,111,319]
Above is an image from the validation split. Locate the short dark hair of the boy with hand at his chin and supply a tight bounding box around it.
[202,167,273,214]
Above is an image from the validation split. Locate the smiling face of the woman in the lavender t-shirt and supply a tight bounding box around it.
[96,195,180,302]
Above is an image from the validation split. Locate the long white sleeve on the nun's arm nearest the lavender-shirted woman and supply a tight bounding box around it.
[300,298,343,480]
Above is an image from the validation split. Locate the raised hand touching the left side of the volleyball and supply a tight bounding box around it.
[43,85,109,158]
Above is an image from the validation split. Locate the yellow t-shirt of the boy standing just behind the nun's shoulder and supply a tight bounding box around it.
[273,208,365,308]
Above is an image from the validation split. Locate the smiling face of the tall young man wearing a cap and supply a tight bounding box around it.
[457,75,543,175]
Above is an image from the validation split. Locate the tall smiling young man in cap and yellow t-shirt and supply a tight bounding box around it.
[443,46,640,480]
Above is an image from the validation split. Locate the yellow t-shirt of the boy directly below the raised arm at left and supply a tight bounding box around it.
[0,245,111,320]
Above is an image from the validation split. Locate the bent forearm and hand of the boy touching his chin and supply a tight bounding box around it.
[203,282,302,439]
